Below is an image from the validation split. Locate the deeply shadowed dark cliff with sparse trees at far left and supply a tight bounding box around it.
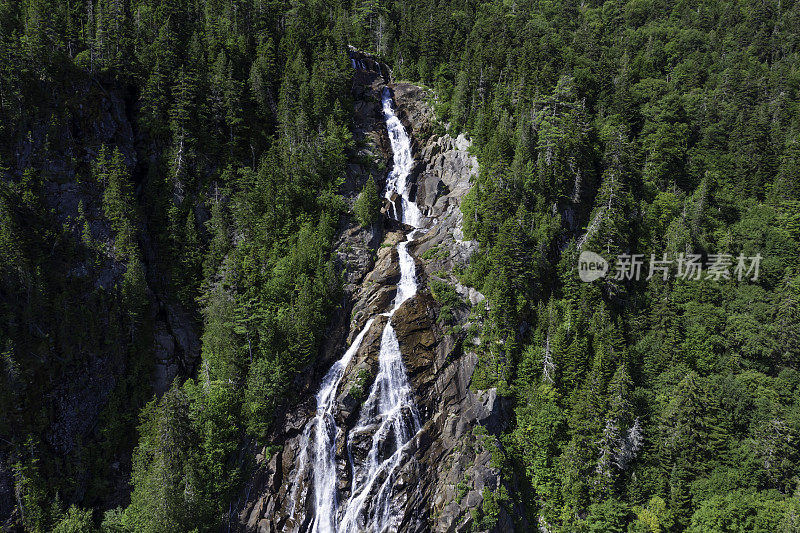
[0,77,200,523]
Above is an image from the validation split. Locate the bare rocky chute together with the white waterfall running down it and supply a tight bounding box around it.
[240,51,514,533]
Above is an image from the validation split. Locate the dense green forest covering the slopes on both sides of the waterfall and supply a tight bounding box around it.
[0,0,800,533]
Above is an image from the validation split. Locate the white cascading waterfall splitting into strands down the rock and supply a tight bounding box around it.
[292,83,424,533]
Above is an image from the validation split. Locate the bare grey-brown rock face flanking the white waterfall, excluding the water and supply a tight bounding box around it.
[234,53,525,532]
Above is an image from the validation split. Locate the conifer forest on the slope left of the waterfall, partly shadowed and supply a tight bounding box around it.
[0,0,350,531]
